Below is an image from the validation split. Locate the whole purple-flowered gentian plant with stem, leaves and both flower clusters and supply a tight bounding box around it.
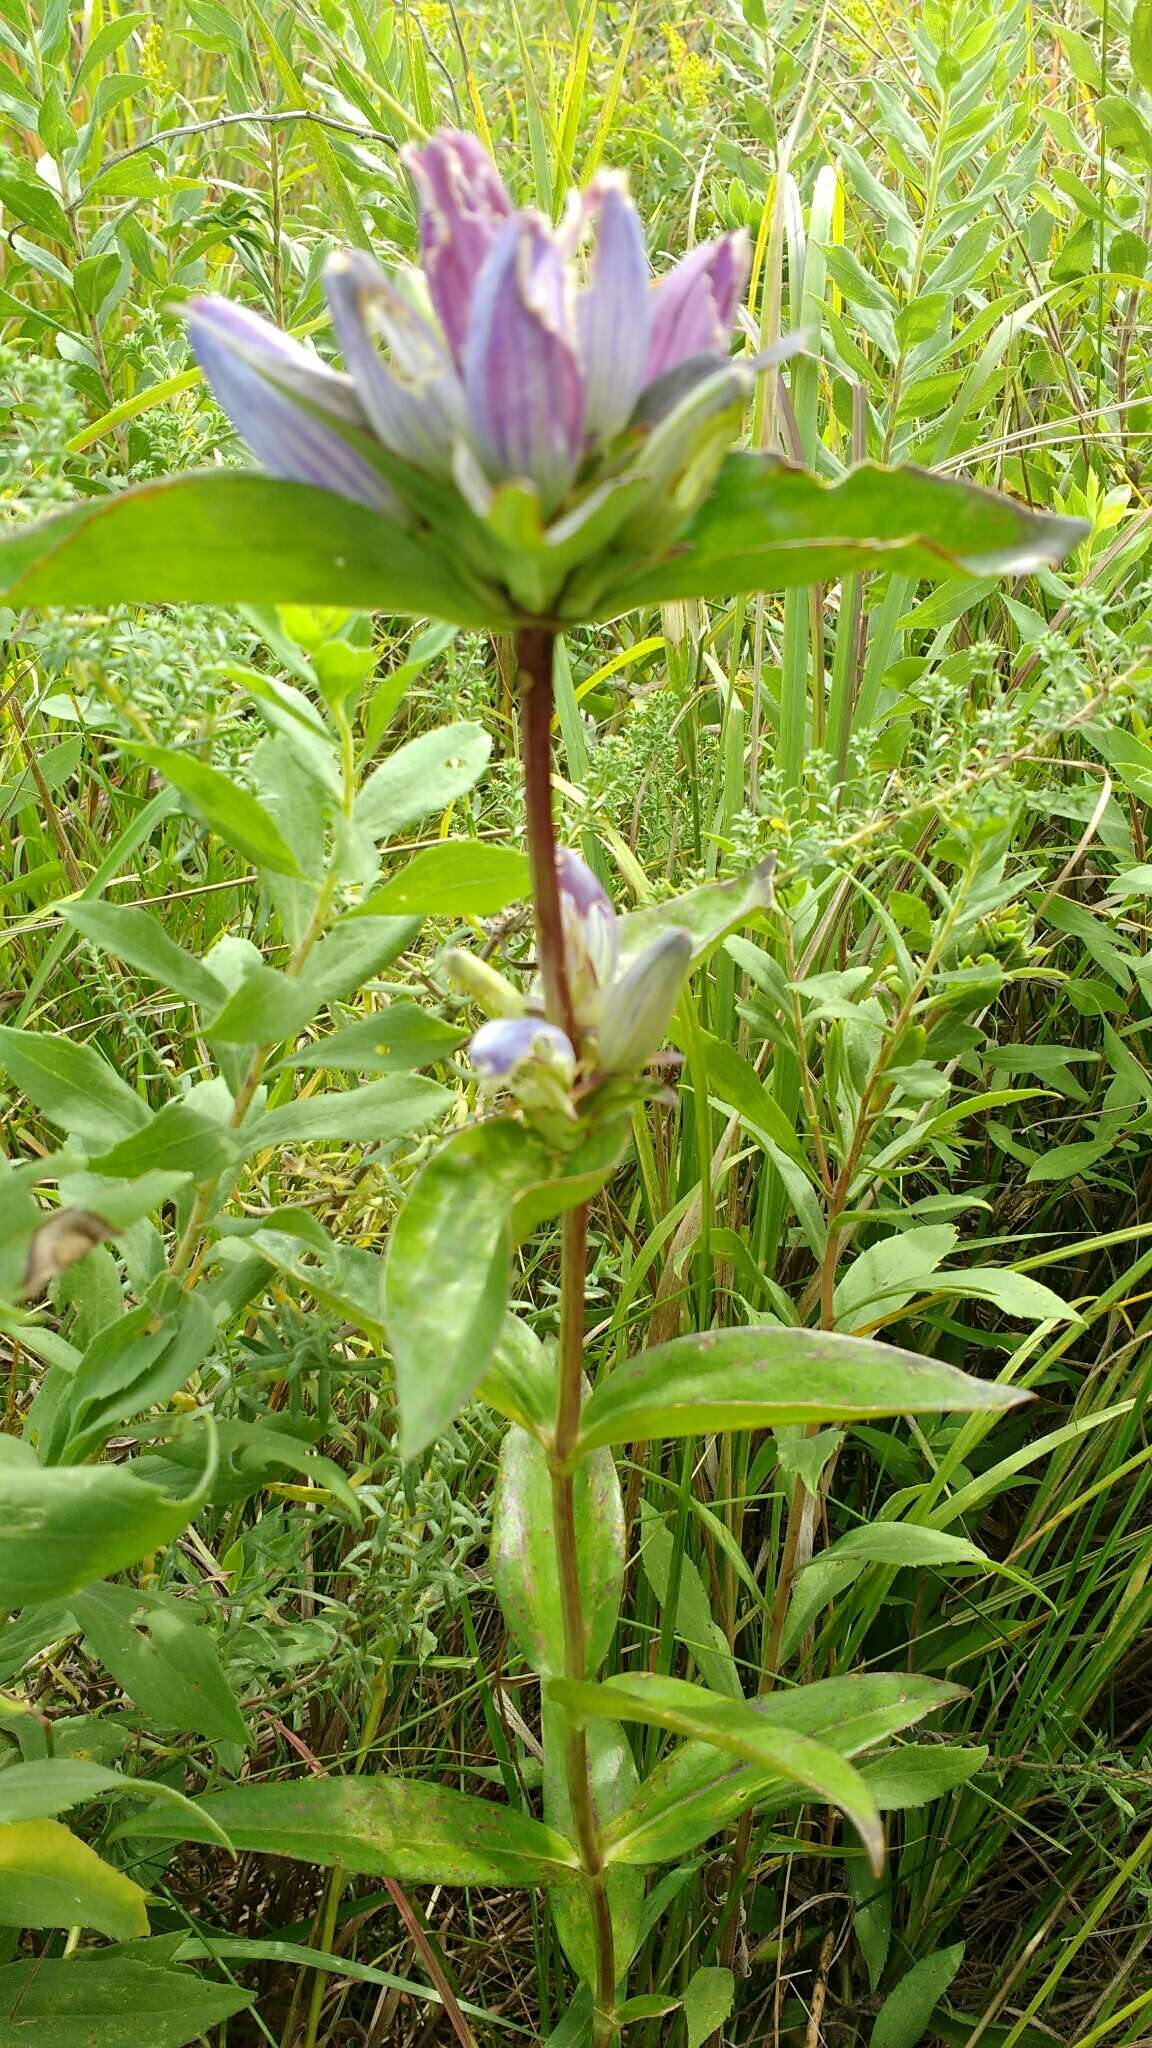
[0,133,1080,2048]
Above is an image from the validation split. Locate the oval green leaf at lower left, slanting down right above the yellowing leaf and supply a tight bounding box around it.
[72,1585,248,1747]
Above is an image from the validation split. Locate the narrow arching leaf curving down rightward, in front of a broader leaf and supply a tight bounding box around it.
[547,1671,883,1872]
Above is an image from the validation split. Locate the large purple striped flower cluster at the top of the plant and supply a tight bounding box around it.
[189,129,762,602]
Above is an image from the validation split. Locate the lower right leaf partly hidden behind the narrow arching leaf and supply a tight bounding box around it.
[605,1671,959,1864]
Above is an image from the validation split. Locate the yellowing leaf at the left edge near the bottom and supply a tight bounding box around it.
[0,1821,148,1933]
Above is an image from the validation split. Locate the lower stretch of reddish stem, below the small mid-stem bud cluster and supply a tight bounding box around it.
[551,1206,617,2048]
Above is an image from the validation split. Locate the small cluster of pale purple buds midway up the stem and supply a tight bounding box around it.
[449,848,693,1114]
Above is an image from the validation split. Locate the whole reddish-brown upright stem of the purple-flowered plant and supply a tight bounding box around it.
[517,627,619,2048]
